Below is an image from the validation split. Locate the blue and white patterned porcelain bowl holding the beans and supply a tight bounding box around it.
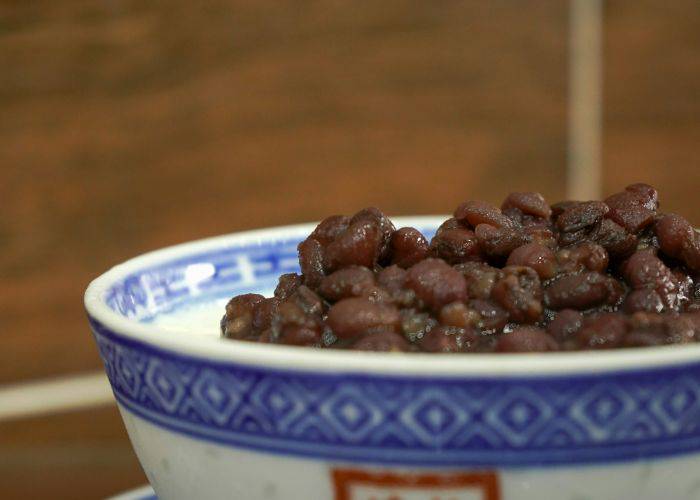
[85,217,700,500]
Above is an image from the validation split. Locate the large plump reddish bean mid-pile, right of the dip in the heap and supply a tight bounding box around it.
[406,258,467,310]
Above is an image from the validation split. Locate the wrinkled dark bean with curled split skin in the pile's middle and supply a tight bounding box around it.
[491,266,542,323]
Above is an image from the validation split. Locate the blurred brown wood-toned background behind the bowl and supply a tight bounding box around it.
[0,0,700,498]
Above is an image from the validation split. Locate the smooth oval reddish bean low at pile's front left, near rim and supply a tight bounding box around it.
[326,298,400,339]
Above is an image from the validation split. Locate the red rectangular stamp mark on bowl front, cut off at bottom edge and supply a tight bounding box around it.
[332,469,501,500]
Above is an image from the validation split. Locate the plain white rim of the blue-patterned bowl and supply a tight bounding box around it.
[84,215,700,377]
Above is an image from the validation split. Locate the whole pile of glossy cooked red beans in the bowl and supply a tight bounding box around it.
[221,184,700,353]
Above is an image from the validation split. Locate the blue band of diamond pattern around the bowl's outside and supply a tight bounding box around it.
[91,319,700,467]
